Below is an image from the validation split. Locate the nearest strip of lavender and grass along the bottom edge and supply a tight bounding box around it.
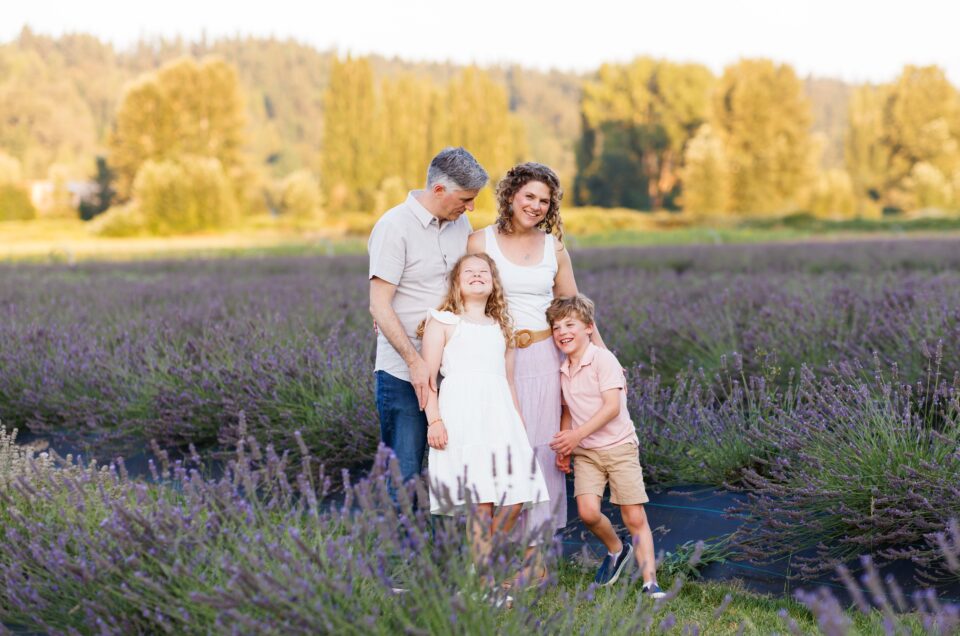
[0,428,960,635]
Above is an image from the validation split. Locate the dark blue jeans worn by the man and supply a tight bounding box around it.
[376,371,427,482]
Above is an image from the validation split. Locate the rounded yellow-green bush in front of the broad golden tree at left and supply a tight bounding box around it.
[133,155,239,234]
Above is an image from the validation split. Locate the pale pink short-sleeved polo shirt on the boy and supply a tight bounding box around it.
[560,343,640,449]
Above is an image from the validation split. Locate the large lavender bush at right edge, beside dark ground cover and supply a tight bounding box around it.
[734,356,960,579]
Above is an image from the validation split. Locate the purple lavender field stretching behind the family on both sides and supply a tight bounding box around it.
[0,240,960,632]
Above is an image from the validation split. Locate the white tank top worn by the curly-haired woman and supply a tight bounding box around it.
[483,225,557,331]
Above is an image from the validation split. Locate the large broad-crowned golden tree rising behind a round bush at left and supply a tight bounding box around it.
[110,59,245,199]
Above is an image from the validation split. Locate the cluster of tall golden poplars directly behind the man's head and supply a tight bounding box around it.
[322,58,526,215]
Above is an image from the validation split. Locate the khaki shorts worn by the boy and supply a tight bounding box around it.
[573,442,650,506]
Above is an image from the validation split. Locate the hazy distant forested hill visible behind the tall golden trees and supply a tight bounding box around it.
[0,28,851,186]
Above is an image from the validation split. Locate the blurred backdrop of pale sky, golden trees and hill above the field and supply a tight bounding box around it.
[0,0,960,256]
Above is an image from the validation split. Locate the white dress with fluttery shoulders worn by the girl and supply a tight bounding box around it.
[428,309,548,514]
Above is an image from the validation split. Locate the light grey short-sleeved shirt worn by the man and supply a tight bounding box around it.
[367,191,471,382]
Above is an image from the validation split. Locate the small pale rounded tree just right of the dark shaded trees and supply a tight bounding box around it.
[681,124,731,216]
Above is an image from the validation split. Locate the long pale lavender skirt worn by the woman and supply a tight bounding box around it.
[513,338,567,530]
